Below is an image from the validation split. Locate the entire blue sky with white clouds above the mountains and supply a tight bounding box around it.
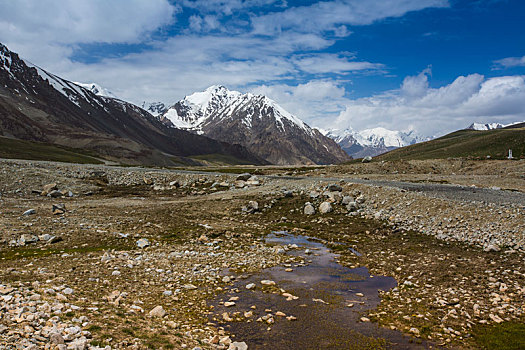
[0,0,525,136]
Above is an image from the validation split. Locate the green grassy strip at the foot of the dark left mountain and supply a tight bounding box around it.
[0,137,103,164]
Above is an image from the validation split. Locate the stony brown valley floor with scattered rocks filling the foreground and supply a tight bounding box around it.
[0,160,525,349]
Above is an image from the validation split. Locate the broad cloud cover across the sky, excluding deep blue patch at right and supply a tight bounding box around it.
[0,0,525,136]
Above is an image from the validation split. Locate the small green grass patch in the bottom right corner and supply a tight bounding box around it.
[474,322,525,350]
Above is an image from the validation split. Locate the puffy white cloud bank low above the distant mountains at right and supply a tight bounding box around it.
[336,70,525,136]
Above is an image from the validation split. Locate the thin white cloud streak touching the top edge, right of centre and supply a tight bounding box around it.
[252,0,449,35]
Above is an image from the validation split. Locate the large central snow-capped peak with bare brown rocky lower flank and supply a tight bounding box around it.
[159,85,349,164]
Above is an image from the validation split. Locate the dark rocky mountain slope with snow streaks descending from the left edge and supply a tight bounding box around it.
[0,44,264,165]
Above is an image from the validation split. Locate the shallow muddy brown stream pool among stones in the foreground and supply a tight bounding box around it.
[214,232,429,349]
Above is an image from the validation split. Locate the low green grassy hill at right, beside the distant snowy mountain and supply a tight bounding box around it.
[375,128,525,160]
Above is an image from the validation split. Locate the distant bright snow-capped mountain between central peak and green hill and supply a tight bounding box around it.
[325,127,425,158]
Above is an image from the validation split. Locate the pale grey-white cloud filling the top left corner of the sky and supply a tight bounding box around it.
[0,0,177,44]
